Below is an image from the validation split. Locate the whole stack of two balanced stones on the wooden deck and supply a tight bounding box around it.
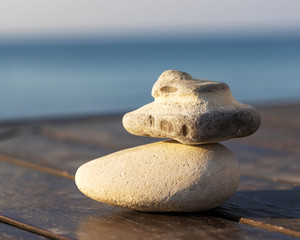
[75,70,260,212]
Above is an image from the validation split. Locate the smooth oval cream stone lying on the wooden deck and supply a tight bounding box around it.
[75,140,240,212]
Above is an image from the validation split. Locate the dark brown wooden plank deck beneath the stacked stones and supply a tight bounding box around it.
[0,104,300,239]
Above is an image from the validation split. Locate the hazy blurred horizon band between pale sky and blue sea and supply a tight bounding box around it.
[0,30,300,44]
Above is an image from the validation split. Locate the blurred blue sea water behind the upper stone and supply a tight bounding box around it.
[0,38,300,120]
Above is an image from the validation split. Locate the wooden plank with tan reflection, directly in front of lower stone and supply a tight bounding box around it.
[0,162,292,239]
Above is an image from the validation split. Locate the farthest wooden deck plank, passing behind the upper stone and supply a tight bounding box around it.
[32,104,300,154]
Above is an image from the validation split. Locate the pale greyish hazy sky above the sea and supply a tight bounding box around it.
[0,0,300,39]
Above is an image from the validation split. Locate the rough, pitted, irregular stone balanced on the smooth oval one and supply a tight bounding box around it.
[123,70,260,145]
